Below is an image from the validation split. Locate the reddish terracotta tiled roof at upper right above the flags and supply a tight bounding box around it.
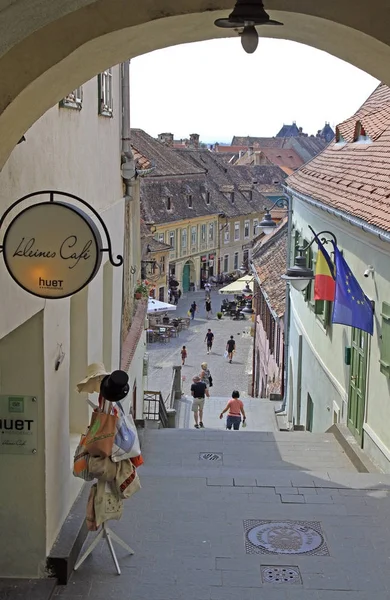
[287,84,390,231]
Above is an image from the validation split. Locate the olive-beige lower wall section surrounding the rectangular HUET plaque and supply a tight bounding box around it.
[0,309,45,577]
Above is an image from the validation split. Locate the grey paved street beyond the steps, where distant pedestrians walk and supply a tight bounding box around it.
[147,290,253,398]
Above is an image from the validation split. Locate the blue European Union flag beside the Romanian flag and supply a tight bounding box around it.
[332,244,374,335]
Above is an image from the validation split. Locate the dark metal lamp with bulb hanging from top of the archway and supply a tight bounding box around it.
[214,0,283,54]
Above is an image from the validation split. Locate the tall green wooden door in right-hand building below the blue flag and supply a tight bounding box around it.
[348,327,368,445]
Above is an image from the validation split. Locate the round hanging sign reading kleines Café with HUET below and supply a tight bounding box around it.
[3,202,102,299]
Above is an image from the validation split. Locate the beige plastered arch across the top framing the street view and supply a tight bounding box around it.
[0,0,390,168]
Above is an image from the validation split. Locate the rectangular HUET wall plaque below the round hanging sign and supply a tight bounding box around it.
[0,396,38,454]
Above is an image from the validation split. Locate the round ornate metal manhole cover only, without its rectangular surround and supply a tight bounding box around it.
[247,521,324,554]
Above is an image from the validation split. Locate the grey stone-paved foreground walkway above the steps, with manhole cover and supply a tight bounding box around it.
[56,424,390,600]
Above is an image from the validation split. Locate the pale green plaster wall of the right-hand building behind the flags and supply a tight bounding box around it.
[290,197,390,468]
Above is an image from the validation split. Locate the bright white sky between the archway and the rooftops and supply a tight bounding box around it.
[130,38,379,143]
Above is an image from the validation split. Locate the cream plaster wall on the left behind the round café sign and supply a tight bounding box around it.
[0,68,130,577]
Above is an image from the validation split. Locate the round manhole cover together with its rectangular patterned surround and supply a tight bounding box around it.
[244,519,329,556]
